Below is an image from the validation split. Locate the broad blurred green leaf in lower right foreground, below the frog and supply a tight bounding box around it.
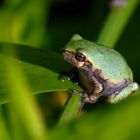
[50,90,140,140]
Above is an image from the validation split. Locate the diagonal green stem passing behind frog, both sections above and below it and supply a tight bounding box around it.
[59,0,139,125]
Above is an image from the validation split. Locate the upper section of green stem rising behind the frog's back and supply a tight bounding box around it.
[97,0,139,47]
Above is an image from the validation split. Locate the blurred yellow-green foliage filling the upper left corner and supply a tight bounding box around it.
[0,0,51,47]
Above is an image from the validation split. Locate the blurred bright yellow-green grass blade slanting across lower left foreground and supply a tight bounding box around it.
[4,50,47,140]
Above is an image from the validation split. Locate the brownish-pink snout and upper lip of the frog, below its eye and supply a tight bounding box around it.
[62,50,85,68]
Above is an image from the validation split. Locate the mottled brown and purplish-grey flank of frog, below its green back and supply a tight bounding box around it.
[82,61,132,96]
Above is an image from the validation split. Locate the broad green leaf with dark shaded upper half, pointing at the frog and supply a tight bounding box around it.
[0,43,80,103]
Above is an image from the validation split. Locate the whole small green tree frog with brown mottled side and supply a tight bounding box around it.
[62,34,139,104]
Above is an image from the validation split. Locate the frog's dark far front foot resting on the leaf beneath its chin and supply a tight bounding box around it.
[59,71,79,84]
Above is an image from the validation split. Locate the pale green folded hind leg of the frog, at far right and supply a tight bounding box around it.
[108,82,138,103]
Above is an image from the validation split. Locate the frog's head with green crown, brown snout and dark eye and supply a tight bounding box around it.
[63,34,94,68]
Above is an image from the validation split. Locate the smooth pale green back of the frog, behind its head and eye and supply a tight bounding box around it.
[77,40,133,83]
